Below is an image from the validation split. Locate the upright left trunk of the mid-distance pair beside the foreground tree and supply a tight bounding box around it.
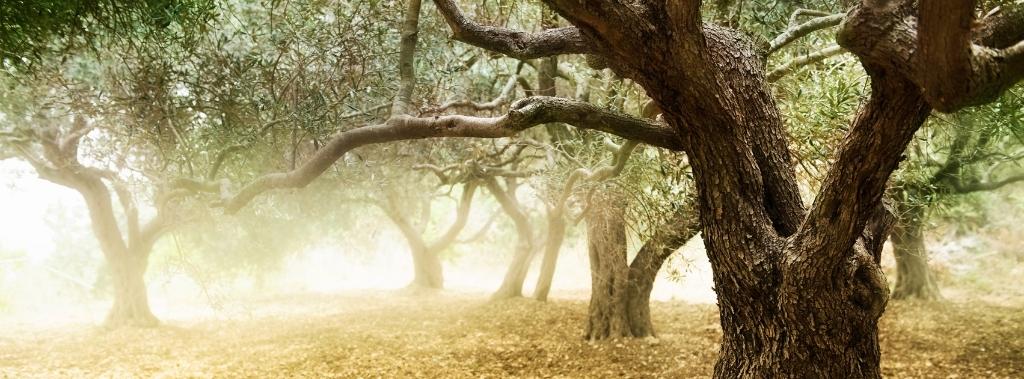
[584,198,633,341]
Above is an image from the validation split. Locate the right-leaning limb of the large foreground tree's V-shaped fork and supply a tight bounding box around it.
[792,72,931,279]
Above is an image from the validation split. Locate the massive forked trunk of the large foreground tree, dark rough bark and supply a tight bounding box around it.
[547,0,929,378]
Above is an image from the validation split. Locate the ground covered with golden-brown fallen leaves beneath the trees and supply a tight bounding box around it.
[0,291,1024,378]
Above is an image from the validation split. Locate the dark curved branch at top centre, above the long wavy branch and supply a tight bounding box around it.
[434,0,592,59]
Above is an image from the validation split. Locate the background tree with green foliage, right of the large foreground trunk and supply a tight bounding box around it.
[890,91,1024,300]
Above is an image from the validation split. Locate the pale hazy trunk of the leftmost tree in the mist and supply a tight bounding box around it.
[106,254,159,328]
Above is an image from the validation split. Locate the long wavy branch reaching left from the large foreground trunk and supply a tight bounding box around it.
[225,97,679,213]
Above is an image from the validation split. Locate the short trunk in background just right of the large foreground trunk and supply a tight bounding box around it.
[890,217,941,300]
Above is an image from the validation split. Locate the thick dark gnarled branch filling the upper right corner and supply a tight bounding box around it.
[838,1,1024,113]
